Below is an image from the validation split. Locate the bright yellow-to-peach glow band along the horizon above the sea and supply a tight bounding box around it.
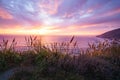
[0,27,101,36]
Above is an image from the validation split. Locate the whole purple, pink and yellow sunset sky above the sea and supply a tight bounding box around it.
[0,0,120,35]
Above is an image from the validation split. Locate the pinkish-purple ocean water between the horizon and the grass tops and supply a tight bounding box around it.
[0,35,103,50]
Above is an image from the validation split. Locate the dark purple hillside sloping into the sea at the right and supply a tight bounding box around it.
[97,28,120,39]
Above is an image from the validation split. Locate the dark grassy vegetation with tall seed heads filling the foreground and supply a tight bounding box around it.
[0,37,120,80]
